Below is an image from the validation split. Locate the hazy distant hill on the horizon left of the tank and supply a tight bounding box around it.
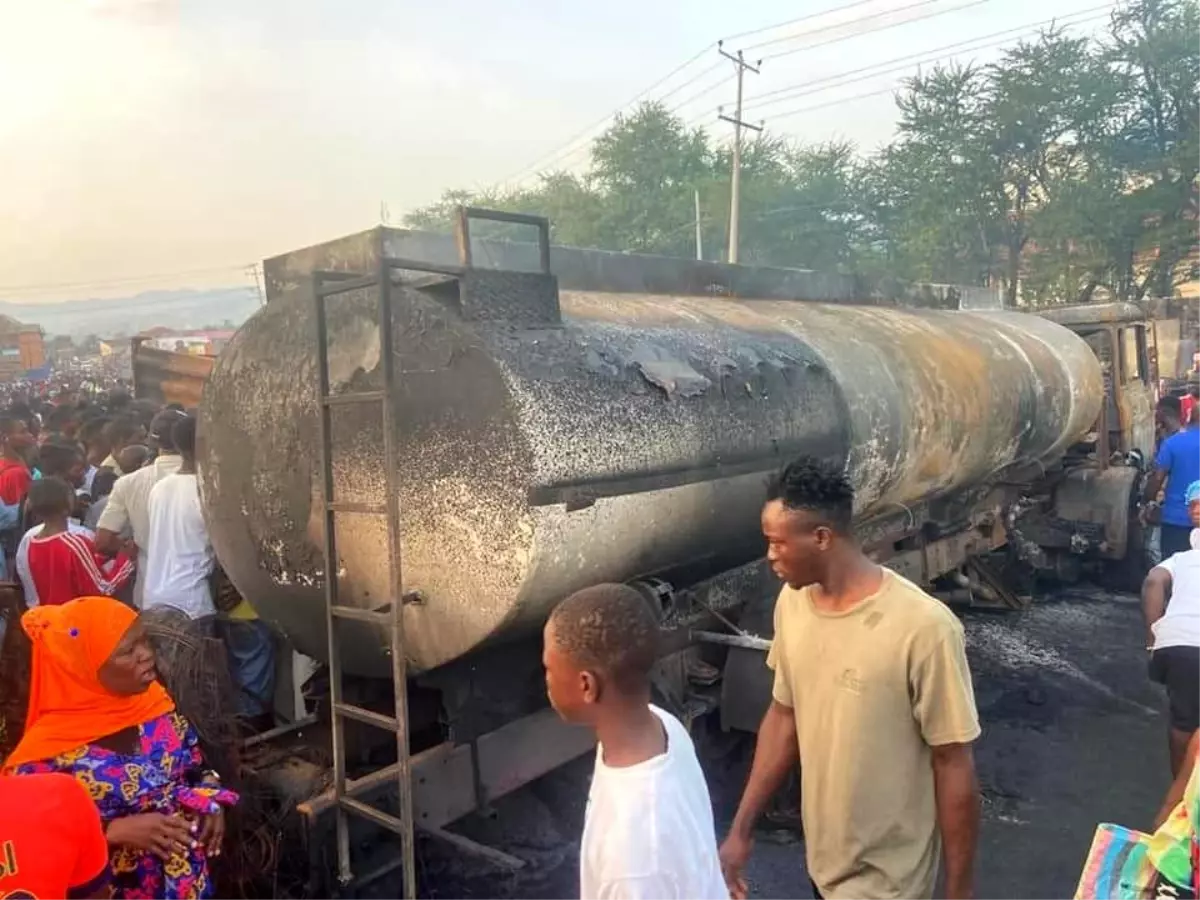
[0,287,259,338]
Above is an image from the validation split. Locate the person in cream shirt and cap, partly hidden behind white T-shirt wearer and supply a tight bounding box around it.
[96,409,186,610]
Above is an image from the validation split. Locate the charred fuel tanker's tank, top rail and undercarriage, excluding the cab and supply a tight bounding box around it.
[199,210,1151,897]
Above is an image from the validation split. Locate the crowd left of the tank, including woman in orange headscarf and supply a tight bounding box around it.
[0,390,275,900]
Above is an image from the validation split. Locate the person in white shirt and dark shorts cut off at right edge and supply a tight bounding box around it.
[1141,481,1200,775]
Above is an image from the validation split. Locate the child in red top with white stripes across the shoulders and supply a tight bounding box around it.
[17,478,133,607]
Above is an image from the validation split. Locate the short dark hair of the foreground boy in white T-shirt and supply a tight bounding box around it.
[550,584,659,692]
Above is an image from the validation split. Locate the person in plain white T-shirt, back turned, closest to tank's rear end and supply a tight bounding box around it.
[141,416,217,620]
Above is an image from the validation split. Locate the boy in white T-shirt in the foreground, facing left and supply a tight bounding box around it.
[542,584,728,900]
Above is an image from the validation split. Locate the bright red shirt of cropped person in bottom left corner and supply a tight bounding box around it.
[0,774,112,900]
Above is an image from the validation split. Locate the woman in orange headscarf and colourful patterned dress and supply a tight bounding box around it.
[5,596,238,900]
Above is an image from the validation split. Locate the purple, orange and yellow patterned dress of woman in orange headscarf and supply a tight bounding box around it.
[17,713,238,900]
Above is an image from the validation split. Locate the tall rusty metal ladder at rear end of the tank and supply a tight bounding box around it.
[313,253,416,900]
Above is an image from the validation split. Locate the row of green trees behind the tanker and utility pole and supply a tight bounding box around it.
[407,0,1200,304]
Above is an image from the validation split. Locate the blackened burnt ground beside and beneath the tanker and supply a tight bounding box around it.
[376,589,1168,900]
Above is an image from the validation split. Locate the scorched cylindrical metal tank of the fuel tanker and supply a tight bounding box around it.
[200,286,1103,674]
